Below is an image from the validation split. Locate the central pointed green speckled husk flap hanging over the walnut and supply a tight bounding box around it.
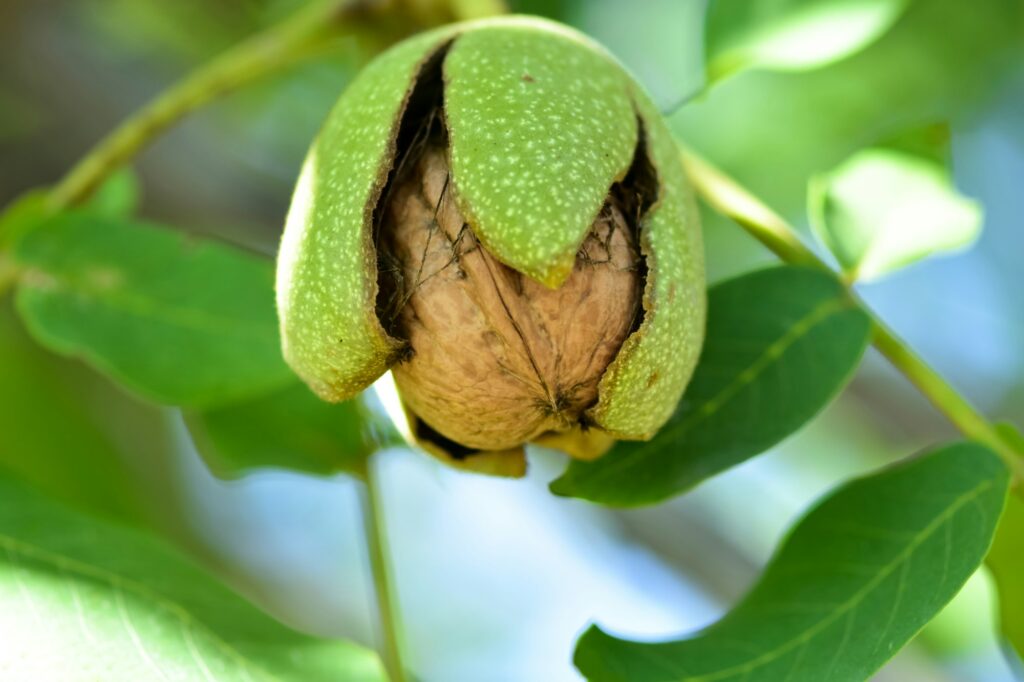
[444,18,637,288]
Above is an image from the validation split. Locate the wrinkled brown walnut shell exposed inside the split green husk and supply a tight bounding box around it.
[379,147,642,450]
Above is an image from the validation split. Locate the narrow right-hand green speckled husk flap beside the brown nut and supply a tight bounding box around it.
[588,86,707,440]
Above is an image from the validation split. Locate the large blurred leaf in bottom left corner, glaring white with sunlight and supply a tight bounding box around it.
[0,471,384,682]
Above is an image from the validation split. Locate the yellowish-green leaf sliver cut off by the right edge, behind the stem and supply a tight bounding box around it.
[985,424,1024,658]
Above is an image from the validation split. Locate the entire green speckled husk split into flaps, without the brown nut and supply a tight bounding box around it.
[278,17,705,439]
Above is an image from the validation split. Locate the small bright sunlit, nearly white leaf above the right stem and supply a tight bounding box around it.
[808,148,982,280]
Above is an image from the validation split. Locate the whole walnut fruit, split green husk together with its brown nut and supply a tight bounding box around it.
[278,16,705,475]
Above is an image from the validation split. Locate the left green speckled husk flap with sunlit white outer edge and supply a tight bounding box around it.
[276,29,452,400]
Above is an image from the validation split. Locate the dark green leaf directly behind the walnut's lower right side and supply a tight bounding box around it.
[551,266,870,506]
